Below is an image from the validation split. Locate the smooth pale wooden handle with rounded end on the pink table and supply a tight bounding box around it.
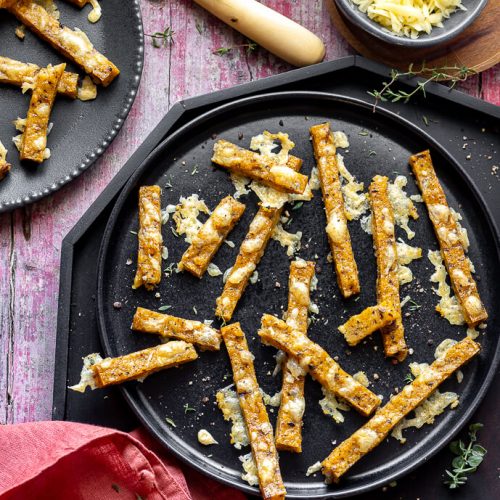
[194,0,325,66]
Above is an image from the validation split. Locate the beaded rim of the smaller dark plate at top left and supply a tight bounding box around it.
[0,0,144,213]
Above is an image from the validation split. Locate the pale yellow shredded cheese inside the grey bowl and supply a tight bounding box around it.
[351,0,467,39]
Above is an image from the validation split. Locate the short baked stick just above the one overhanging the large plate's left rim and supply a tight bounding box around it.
[132,307,221,351]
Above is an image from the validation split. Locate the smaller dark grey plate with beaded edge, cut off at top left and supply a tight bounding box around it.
[0,0,144,212]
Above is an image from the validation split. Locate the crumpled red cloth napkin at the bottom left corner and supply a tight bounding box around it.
[0,422,246,500]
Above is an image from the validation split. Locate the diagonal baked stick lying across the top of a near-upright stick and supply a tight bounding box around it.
[259,314,380,416]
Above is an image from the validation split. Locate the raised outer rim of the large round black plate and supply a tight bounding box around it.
[96,91,500,499]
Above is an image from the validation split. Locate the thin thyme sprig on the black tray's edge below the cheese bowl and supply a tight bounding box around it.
[368,63,476,111]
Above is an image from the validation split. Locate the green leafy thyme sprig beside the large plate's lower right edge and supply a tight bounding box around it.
[445,424,486,490]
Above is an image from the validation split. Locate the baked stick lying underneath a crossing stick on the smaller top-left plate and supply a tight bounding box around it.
[0,56,78,99]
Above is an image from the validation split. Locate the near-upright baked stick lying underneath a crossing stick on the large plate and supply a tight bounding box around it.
[276,260,314,453]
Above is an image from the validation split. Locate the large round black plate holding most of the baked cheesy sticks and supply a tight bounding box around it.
[98,92,500,498]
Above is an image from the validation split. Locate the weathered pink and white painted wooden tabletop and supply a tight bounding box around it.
[0,0,500,424]
